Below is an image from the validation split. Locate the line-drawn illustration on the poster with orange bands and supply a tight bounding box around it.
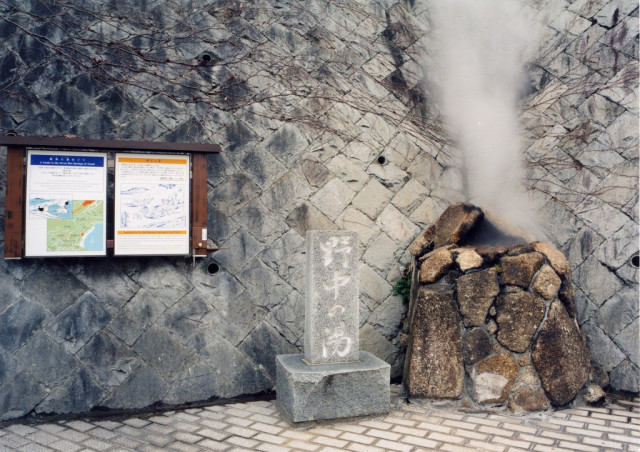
[120,184,188,229]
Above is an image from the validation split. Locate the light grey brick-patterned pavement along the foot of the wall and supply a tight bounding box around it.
[0,386,640,452]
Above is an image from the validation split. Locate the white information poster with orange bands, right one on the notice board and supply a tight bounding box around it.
[114,153,190,256]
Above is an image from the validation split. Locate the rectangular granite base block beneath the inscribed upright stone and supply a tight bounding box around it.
[276,351,391,422]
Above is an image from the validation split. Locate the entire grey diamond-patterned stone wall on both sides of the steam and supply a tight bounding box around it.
[0,0,639,420]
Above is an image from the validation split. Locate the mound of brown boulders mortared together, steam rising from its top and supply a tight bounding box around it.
[403,203,604,411]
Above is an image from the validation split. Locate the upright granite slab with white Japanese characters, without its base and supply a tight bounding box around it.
[304,231,360,364]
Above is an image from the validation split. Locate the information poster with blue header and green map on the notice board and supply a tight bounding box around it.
[25,150,107,257]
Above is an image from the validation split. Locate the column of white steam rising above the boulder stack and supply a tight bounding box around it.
[426,0,543,238]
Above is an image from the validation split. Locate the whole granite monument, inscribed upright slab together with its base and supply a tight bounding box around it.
[276,231,391,422]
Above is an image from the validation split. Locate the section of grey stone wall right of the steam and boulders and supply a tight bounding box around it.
[523,0,640,393]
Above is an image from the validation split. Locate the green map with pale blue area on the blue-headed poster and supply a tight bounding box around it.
[47,200,104,251]
